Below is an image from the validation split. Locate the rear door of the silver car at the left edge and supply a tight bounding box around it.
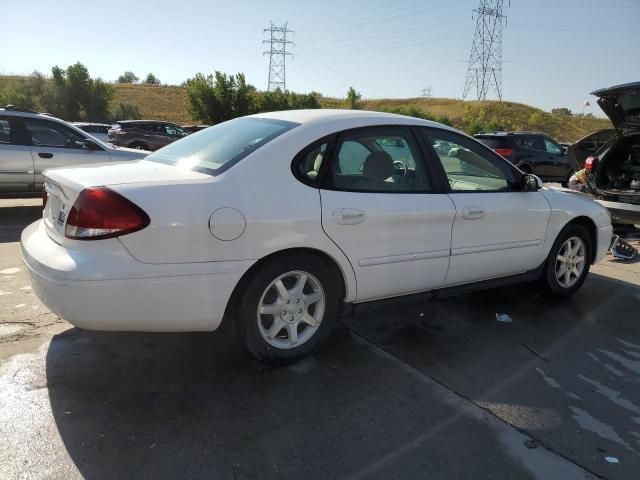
[0,115,34,193]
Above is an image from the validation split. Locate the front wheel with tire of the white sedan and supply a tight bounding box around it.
[540,224,593,297]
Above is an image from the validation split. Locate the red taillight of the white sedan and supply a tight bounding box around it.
[64,187,149,240]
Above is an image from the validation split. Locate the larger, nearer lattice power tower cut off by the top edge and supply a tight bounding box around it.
[462,0,510,101]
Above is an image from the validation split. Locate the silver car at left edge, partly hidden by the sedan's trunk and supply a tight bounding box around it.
[0,107,149,196]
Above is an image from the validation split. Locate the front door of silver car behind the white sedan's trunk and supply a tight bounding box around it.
[25,118,111,189]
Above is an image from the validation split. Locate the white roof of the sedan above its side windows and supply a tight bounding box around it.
[251,108,454,130]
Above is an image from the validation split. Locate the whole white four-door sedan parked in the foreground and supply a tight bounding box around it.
[22,110,612,362]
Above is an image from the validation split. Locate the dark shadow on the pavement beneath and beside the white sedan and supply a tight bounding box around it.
[46,275,640,479]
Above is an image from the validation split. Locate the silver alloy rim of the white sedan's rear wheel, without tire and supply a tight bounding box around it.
[257,270,325,349]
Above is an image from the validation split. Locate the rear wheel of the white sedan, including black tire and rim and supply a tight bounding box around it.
[235,253,340,364]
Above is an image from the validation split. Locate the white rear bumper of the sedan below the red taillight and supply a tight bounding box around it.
[21,220,253,332]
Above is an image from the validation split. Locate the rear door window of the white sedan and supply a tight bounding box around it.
[328,127,431,192]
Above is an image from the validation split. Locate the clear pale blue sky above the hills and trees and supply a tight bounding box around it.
[0,0,640,115]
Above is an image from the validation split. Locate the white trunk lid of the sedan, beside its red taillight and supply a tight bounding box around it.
[42,160,212,245]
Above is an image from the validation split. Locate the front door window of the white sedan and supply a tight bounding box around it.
[423,129,517,192]
